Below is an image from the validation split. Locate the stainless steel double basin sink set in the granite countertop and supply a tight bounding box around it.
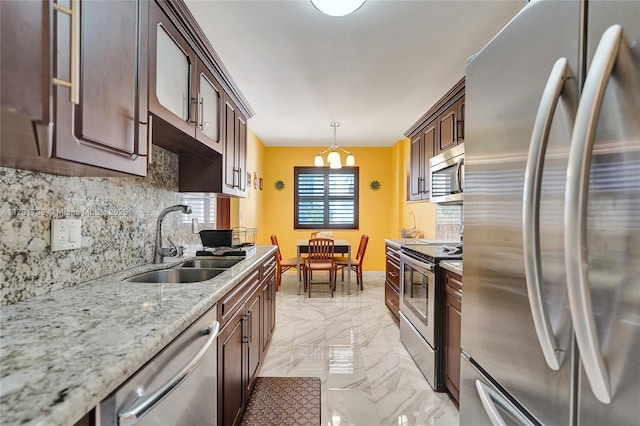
[125,259,241,283]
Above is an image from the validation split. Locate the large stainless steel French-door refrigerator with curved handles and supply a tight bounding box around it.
[460,0,640,426]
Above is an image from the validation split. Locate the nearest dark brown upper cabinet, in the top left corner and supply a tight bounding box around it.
[0,0,148,176]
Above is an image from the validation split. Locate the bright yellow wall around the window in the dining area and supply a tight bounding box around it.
[238,130,435,271]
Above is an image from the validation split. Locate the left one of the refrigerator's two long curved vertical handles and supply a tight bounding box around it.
[522,58,571,371]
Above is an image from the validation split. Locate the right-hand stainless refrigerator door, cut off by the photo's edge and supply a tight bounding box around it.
[568,1,640,425]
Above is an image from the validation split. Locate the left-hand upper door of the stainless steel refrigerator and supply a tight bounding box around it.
[460,1,582,425]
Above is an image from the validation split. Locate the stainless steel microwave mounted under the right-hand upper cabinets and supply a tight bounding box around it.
[429,144,464,204]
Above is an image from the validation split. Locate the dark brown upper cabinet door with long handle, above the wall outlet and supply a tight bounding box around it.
[53,0,148,176]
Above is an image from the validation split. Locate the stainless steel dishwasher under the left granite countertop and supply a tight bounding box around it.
[100,306,220,426]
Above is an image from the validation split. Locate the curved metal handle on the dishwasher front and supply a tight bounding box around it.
[118,321,220,426]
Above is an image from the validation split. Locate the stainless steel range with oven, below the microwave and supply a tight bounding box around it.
[400,243,462,390]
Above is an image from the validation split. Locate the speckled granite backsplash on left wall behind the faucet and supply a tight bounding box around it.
[0,147,213,305]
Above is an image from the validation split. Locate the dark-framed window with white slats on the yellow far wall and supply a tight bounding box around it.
[293,167,358,229]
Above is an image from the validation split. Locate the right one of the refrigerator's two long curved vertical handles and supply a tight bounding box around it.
[564,25,622,404]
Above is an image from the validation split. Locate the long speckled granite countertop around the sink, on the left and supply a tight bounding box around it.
[0,245,276,426]
